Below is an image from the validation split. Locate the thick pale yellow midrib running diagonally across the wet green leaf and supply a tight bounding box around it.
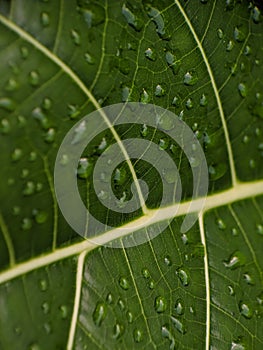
[0,180,263,284]
